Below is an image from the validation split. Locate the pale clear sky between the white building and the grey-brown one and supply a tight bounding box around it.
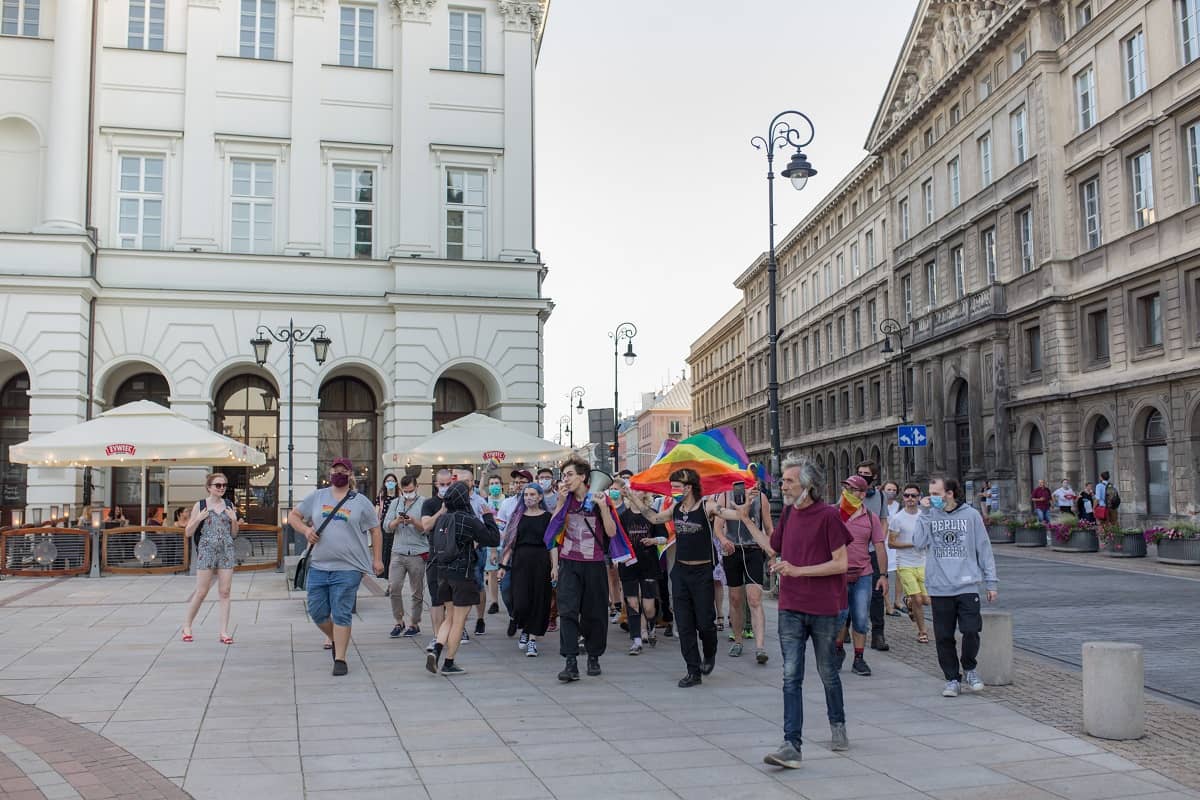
[535,0,917,445]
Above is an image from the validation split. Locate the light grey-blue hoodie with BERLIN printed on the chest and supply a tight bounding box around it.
[912,503,997,597]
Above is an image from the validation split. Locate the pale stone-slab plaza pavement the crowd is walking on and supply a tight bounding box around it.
[0,561,1200,800]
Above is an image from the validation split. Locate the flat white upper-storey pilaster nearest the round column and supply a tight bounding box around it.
[175,0,224,251]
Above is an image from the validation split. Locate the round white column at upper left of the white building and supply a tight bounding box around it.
[35,2,92,234]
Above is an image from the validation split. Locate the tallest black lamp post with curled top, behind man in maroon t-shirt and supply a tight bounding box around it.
[750,110,817,515]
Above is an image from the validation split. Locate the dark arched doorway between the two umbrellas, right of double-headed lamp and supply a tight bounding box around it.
[317,377,379,498]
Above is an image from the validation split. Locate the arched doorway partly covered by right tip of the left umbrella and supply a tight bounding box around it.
[216,375,280,525]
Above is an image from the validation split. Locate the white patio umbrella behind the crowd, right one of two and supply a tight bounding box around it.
[383,414,571,467]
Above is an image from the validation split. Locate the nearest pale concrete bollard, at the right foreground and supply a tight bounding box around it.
[1084,642,1146,740]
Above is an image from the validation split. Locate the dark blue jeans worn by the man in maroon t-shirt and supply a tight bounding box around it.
[779,614,844,750]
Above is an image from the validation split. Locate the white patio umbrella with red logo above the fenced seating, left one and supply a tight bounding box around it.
[8,401,266,524]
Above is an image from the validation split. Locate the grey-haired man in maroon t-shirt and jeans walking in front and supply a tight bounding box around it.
[763,459,852,769]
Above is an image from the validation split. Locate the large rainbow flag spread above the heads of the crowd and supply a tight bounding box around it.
[629,428,758,497]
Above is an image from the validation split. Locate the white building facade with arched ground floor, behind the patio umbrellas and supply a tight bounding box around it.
[0,0,552,525]
